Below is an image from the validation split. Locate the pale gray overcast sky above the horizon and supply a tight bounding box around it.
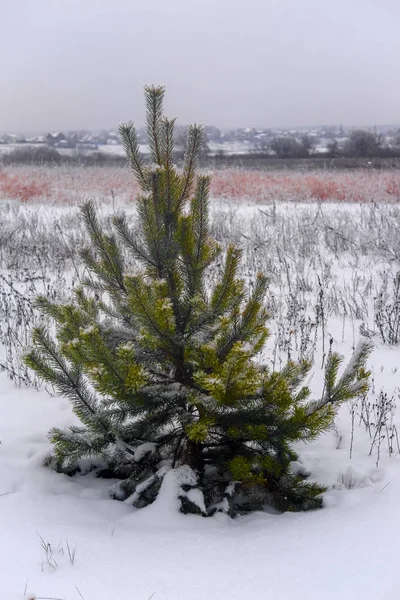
[0,0,400,131]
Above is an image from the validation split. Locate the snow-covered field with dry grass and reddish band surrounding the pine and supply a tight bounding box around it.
[0,176,400,600]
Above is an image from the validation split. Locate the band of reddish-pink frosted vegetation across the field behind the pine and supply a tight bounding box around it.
[0,166,400,204]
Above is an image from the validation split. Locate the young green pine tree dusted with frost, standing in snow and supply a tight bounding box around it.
[26,87,369,515]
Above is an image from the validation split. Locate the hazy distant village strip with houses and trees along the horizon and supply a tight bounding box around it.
[0,126,400,158]
